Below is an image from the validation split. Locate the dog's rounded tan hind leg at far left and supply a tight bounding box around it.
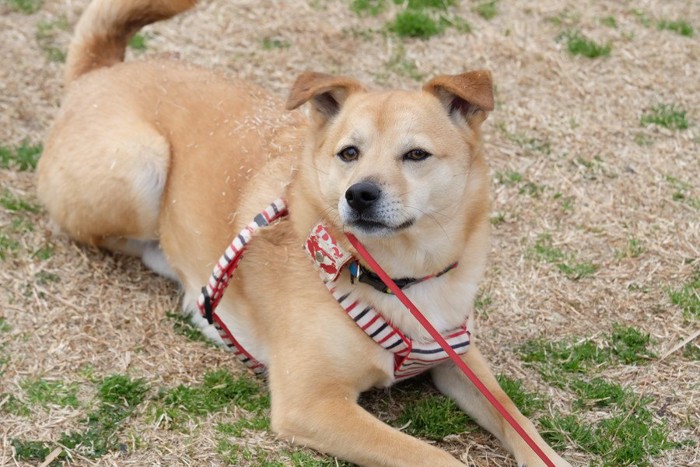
[37,120,172,260]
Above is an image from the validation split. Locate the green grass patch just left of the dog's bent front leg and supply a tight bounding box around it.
[155,370,270,427]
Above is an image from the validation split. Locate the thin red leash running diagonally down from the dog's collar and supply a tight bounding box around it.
[345,232,556,467]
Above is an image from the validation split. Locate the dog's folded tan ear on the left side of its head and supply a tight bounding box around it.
[287,71,364,121]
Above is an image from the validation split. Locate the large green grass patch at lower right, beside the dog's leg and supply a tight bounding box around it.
[521,325,678,466]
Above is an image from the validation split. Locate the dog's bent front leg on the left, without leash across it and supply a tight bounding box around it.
[270,371,464,467]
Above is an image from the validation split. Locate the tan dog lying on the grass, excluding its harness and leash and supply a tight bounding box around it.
[38,0,567,467]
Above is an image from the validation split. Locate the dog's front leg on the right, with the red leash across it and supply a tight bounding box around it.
[432,344,569,467]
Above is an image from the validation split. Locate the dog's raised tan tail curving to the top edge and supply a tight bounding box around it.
[65,0,197,86]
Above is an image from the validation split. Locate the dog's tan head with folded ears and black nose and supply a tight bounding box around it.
[287,71,493,272]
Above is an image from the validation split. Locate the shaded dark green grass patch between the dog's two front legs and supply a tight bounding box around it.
[393,394,471,440]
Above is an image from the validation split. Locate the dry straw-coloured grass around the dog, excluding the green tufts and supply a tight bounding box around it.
[0,0,700,466]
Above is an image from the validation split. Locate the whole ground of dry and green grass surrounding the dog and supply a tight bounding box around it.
[0,0,700,466]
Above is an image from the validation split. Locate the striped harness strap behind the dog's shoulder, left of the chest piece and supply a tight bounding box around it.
[197,198,288,374]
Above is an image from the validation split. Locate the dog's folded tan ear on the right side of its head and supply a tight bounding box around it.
[423,70,493,127]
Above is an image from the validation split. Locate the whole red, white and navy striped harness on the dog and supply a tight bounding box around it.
[197,199,471,381]
